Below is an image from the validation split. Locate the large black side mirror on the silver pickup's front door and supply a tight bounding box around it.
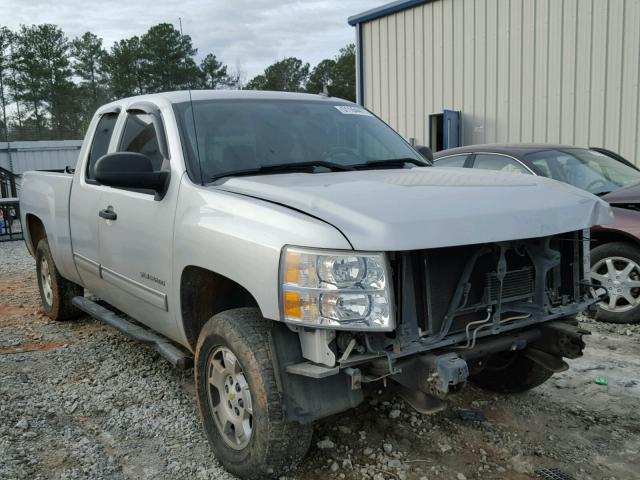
[95,152,169,200]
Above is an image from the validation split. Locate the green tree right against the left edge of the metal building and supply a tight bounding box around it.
[307,44,356,102]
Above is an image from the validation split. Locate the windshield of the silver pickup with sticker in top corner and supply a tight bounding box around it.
[174,99,427,183]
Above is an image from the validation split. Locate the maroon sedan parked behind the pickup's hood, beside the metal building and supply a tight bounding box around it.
[433,144,640,323]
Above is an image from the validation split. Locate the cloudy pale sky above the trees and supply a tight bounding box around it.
[0,0,385,78]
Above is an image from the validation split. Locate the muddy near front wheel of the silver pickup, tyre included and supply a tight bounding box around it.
[195,308,313,479]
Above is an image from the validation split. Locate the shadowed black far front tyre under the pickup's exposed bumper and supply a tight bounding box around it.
[469,351,553,393]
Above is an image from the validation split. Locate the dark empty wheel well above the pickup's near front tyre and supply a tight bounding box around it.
[180,265,260,351]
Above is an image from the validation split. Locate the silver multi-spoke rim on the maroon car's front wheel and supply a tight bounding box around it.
[590,257,640,313]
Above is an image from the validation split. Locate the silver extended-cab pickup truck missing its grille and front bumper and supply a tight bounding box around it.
[20,91,612,478]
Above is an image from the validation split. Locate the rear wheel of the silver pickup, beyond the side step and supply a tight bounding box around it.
[36,238,84,321]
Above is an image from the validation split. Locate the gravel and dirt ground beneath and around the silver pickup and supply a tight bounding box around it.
[0,242,640,480]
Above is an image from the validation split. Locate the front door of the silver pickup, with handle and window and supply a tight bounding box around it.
[95,109,178,335]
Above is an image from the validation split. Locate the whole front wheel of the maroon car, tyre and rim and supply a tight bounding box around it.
[590,242,640,323]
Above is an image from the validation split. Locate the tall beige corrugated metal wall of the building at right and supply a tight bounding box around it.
[362,0,640,163]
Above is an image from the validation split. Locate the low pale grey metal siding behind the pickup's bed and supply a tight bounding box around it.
[0,140,82,174]
